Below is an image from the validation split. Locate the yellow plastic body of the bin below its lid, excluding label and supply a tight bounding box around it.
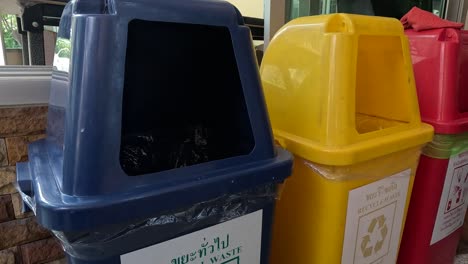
[270,147,420,264]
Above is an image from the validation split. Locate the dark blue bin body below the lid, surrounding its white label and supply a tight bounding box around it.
[54,184,277,264]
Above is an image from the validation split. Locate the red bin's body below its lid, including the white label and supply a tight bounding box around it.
[398,133,468,264]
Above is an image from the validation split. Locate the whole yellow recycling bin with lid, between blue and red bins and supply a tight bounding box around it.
[261,14,433,264]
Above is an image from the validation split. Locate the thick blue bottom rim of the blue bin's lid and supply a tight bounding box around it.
[17,140,292,232]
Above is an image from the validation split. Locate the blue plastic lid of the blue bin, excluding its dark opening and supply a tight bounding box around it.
[17,0,292,232]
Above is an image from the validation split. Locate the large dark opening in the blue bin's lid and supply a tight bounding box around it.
[120,20,255,176]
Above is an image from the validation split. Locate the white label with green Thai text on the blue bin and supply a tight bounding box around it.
[120,210,263,264]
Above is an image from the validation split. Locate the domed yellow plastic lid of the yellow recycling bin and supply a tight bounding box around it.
[260,14,433,165]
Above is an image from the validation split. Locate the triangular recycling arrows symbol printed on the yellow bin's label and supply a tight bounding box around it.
[361,215,388,258]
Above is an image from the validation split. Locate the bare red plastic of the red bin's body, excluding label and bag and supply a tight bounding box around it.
[398,155,462,264]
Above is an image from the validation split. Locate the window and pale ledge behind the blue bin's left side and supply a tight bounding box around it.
[0,0,67,105]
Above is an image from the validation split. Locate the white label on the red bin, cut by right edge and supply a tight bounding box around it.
[434,151,468,245]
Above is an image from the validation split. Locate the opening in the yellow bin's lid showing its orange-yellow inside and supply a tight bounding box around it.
[355,35,411,134]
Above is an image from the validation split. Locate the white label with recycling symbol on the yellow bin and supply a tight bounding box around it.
[341,170,411,264]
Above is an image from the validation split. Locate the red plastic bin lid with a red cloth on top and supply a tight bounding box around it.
[405,28,468,134]
